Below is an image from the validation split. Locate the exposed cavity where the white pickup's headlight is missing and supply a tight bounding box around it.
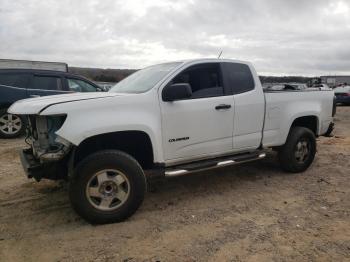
[26,115,71,162]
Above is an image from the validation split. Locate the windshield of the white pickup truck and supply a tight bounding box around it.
[109,62,181,93]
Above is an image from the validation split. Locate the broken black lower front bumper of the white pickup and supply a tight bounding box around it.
[20,148,67,181]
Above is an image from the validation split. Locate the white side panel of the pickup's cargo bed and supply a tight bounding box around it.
[263,88,334,147]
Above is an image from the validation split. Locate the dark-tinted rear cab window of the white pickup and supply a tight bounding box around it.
[221,62,255,94]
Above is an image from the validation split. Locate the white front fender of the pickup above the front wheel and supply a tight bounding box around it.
[41,93,163,162]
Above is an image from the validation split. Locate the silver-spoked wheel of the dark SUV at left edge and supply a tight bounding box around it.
[0,109,25,138]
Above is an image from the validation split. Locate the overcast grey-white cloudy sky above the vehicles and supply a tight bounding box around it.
[0,0,350,75]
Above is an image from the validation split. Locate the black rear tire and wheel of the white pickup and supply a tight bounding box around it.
[278,126,316,173]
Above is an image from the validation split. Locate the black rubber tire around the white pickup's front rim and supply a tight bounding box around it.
[69,150,147,224]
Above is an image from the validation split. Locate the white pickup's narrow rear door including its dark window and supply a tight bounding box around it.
[221,62,265,151]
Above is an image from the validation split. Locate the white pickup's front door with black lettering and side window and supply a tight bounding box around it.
[159,63,234,164]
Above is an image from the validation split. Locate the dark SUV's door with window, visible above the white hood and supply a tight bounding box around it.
[27,74,69,97]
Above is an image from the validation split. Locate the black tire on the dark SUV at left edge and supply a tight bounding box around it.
[0,109,25,138]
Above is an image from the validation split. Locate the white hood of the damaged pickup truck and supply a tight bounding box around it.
[8,92,120,115]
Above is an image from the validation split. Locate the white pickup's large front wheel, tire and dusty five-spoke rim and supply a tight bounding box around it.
[69,150,146,224]
